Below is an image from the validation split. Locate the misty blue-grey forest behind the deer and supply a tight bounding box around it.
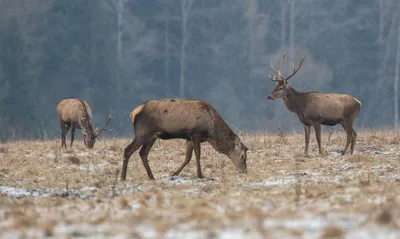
[0,0,400,142]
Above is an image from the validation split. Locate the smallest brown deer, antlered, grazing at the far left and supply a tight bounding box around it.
[57,99,114,149]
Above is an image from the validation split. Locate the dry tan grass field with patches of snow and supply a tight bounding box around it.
[0,131,400,239]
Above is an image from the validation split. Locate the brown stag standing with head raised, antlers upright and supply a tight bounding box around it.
[267,54,361,155]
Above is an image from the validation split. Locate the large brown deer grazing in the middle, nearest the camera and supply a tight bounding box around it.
[121,99,248,181]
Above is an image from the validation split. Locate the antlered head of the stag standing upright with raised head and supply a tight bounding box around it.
[267,54,306,100]
